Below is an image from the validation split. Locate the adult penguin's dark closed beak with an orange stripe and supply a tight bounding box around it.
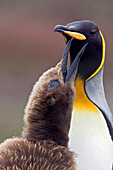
[54,25,86,41]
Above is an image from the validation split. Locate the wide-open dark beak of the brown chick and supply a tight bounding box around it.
[62,38,88,83]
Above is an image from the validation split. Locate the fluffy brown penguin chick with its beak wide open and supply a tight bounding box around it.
[0,39,86,170]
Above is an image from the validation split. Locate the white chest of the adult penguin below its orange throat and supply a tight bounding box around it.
[69,111,113,170]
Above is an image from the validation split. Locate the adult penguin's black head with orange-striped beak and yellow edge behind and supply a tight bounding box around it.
[54,20,105,80]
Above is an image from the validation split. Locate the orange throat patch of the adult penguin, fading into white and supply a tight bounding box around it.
[73,76,99,113]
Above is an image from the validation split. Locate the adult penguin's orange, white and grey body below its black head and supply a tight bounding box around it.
[69,70,113,169]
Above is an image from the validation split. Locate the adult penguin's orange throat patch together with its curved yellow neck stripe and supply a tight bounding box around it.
[73,32,105,114]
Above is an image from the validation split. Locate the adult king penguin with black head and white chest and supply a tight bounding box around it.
[54,20,113,170]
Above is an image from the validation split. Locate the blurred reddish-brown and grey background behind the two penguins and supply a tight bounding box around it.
[0,0,113,141]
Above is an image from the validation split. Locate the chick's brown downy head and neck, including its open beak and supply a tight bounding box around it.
[24,39,87,145]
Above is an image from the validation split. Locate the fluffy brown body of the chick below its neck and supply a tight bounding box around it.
[0,138,76,170]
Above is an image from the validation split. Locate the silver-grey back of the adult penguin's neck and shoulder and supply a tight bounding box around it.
[85,66,112,119]
